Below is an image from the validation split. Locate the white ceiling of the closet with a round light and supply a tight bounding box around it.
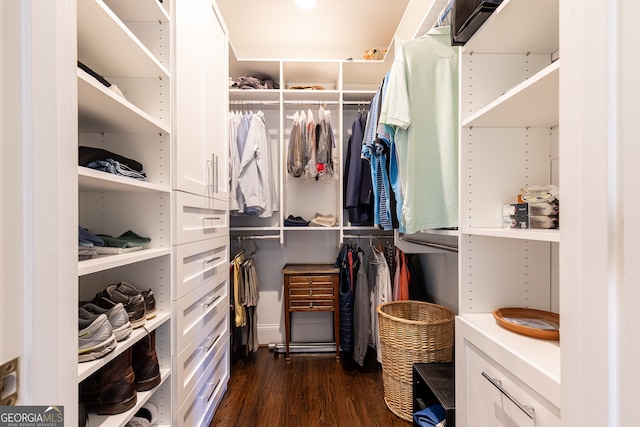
[217,0,416,59]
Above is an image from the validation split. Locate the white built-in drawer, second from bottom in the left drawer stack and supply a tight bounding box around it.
[173,301,229,408]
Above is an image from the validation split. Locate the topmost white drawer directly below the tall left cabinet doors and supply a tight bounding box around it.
[173,191,229,245]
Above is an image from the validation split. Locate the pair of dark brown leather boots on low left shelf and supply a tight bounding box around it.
[79,330,161,415]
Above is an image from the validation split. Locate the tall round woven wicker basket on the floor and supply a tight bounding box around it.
[378,301,454,421]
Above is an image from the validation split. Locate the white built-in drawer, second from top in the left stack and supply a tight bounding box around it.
[172,236,229,300]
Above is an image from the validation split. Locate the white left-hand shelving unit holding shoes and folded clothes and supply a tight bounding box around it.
[77,0,172,426]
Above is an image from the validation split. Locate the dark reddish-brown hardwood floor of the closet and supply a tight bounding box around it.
[211,347,411,427]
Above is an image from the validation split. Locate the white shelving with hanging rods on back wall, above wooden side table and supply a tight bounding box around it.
[229,50,393,245]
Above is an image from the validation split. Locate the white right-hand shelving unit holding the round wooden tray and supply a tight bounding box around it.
[456,0,561,426]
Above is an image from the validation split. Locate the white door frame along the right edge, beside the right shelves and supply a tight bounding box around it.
[560,0,640,427]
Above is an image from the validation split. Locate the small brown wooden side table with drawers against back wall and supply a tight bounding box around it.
[282,264,340,361]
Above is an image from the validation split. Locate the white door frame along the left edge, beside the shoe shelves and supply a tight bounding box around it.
[0,1,78,418]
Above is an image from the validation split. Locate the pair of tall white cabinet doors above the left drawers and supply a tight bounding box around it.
[173,0,228,198]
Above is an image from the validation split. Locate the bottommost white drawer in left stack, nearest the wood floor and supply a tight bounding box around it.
[173,337,230,427]
